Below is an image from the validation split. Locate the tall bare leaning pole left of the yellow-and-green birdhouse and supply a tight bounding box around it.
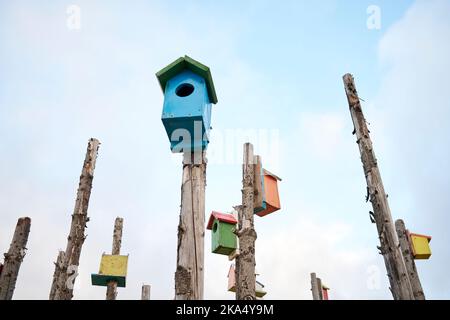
[50,138,100,300]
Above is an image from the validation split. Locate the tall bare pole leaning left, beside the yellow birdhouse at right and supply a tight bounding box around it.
[343,74,414,300]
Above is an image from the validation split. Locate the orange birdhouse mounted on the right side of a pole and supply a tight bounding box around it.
[254,169,281,217]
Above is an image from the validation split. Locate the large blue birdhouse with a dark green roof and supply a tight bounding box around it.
[156,56,217,152]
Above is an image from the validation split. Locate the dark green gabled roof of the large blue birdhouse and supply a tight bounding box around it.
[156,56,217,104]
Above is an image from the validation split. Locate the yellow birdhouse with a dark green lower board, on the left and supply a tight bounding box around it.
[91,254,128,287]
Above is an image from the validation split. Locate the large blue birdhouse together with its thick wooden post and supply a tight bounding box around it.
[156,56,217,300]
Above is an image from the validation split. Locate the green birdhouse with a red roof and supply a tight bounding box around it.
[206,211,237,256]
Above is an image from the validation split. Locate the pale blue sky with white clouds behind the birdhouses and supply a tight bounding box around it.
[0,0,450,299]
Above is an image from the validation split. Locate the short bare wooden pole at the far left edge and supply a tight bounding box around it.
[0,217,31,300]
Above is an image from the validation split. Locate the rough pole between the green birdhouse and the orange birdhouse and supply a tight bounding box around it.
[236,143,257,300]
